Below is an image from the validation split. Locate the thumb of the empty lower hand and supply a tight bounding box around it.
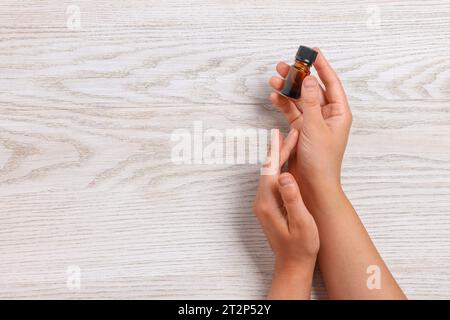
[278,172,307,221]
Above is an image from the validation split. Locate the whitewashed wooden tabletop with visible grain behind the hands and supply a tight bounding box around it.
[0,0,450,299]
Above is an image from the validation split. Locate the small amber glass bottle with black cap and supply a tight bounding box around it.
[280,46,317,100]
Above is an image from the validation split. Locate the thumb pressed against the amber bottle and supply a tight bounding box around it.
[300,76,323,122]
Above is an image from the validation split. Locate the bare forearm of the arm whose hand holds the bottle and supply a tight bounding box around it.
[306,185,405,299]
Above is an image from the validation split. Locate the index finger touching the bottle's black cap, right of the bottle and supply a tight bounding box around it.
[314,48,347,103]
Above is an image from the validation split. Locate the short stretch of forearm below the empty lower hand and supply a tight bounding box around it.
[268,263,314,300]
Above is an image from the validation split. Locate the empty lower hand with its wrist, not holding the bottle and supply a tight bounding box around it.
[253,129,319,299]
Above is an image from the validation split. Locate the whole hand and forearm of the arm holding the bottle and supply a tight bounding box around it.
[270,49,406,299]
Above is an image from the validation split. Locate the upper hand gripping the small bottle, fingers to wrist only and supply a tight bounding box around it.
[270,48,352,192]
